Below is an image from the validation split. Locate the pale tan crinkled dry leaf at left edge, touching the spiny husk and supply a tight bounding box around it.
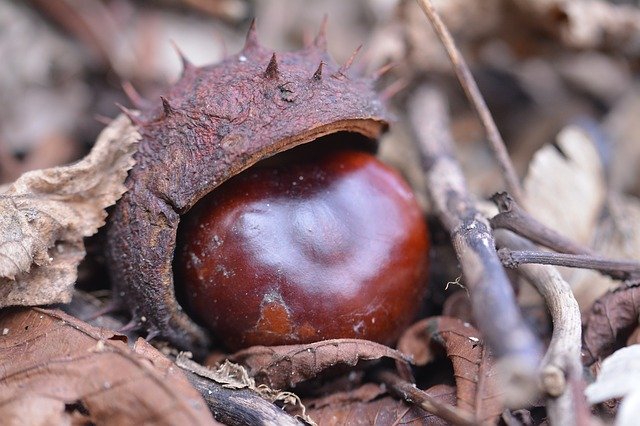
[0,116,140,307]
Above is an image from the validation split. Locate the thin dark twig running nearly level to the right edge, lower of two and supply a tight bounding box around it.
[498,248,640,280]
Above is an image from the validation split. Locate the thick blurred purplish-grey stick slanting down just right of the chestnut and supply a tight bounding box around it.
[409,87,541,404]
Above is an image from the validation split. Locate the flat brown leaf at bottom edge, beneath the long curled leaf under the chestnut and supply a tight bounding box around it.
[305,384,455,426]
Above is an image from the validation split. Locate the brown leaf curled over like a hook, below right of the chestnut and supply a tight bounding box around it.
[398,317,504,423]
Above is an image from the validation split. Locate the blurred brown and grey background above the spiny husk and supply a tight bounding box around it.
[0,0,640,201]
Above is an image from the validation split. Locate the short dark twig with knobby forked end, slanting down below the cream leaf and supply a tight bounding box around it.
[489,192,594,255]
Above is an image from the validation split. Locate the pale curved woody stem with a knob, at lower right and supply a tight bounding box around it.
[495,230,588,425]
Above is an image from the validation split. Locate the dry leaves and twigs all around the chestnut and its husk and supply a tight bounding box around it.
[0,0,640,425]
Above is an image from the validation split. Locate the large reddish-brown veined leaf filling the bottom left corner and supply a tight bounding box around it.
[0,308,216,425]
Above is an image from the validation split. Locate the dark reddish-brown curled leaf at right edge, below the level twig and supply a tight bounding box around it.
[582,285,640,366]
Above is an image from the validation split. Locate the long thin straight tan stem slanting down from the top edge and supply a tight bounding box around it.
[416,0,523,201]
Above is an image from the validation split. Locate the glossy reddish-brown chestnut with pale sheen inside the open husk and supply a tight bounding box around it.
[174,143,428,350]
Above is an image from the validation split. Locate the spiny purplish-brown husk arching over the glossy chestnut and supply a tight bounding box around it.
[106,24,387,352]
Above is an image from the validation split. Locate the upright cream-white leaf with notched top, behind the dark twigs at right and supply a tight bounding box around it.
[523,126,613,311]
